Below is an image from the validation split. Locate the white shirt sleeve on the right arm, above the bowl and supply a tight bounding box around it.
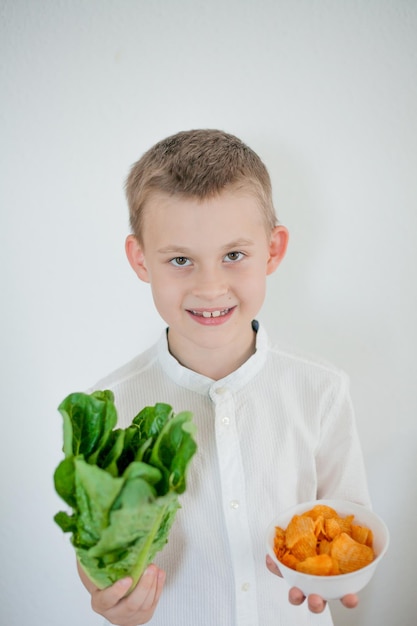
[316,373,371,506]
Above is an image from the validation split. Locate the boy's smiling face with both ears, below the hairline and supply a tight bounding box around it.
[126,191,288,372]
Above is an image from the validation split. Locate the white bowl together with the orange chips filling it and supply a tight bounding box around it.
[267,500,389,600]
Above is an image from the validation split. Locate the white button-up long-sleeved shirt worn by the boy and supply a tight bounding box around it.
[95,327,369,626]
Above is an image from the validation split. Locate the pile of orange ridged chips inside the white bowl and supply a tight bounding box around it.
[274,504,375,576]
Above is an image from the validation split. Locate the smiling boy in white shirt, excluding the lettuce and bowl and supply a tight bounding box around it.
[80,130,368,626]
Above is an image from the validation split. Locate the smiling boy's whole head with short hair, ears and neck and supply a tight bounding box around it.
[122,130,288,380]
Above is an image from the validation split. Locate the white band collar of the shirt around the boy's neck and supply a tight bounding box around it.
[157,321,268,395]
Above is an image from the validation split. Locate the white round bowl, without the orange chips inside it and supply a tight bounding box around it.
[266,500,389,600]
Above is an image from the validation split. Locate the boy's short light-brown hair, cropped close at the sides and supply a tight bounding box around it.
[125,129,277,241]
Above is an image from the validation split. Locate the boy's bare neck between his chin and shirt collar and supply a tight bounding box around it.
[168,329,256,380]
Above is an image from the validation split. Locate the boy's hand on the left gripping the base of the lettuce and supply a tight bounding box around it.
[77,564,165,626]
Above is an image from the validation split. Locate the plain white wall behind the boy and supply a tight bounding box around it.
[0,0,417,626]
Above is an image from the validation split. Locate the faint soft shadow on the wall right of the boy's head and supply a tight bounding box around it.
[252,137,329,348]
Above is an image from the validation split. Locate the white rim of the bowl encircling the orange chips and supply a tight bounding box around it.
[266,498,390,581]
